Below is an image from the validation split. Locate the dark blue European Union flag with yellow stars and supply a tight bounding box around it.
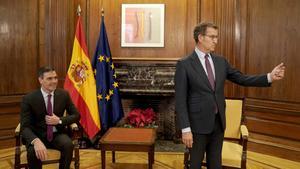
[92,16,124,133]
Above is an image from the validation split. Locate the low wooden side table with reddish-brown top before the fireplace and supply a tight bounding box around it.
[99,127,156,169]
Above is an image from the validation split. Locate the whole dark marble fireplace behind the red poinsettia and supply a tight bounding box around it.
[115,63,176,140]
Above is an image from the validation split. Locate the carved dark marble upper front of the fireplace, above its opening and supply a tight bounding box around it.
[115,63,175,96]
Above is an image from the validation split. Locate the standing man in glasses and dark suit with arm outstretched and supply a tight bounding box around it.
[175,22,285,169]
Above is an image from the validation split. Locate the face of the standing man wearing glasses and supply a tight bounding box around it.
[198,27,218,53]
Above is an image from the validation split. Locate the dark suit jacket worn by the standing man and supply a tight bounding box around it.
[175,51,270,134]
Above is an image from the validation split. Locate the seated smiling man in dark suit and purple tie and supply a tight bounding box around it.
[21,67,80,169]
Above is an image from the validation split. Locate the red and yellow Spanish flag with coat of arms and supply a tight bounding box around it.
[64,16,101,139]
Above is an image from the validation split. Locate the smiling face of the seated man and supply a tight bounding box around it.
[39,71,58,93]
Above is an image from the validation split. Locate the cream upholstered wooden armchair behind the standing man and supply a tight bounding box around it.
[184,99,249,169]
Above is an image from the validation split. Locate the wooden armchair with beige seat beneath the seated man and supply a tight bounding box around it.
[15,123,79,169]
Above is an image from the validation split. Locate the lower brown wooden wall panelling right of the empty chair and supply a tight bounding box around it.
[245,98,300,161]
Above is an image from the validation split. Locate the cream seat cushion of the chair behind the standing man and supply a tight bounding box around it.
[222,141,243,168]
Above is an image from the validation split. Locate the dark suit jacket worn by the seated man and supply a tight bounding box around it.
[20,89,80,146]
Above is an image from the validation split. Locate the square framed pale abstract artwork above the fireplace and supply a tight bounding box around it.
[121,4,165,47]
